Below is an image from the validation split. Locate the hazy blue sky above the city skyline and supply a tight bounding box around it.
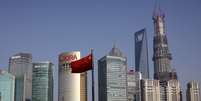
[0,0,201,101]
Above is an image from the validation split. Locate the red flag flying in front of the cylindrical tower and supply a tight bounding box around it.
[70,54,93,73]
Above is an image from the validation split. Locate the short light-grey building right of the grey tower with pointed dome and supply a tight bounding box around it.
[127,70,142,101]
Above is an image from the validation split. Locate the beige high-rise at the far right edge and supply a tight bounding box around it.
[186,81,200,101]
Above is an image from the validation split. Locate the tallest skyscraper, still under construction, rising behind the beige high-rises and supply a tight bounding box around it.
[153,8,176,81]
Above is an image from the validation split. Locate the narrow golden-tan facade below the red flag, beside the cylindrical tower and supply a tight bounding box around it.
[80,72,87,101]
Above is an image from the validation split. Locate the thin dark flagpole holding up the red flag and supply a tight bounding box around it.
[91,49,95,101]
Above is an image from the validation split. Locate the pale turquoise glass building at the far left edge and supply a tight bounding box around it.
[0,70,15,101]
